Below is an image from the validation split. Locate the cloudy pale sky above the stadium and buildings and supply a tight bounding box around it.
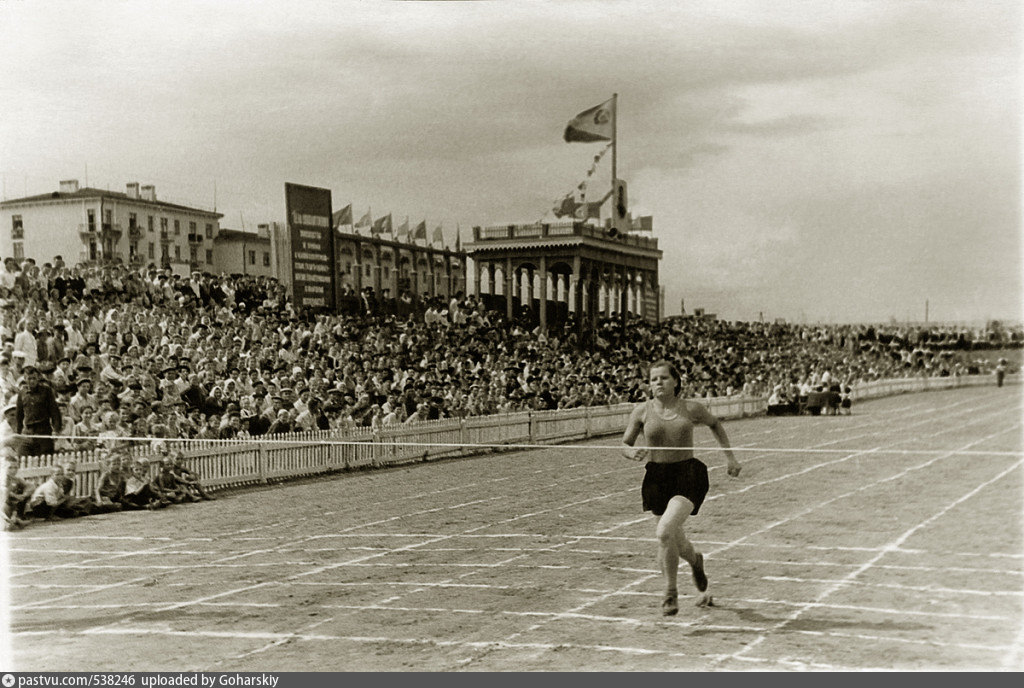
[0,0,1024,323]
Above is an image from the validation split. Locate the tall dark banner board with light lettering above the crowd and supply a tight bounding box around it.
[285,183,336,312]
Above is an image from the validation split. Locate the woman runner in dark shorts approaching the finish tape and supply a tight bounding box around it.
[623,360,740,616]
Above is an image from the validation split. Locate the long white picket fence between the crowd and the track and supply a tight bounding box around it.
[18,376,1020,496]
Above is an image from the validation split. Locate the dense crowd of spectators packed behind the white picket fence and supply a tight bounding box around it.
[0,252,1021,456]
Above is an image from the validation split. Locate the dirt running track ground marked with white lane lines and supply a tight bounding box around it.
[5,385,1024,672]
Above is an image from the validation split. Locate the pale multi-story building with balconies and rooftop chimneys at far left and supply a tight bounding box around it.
[0,179,223,274]
